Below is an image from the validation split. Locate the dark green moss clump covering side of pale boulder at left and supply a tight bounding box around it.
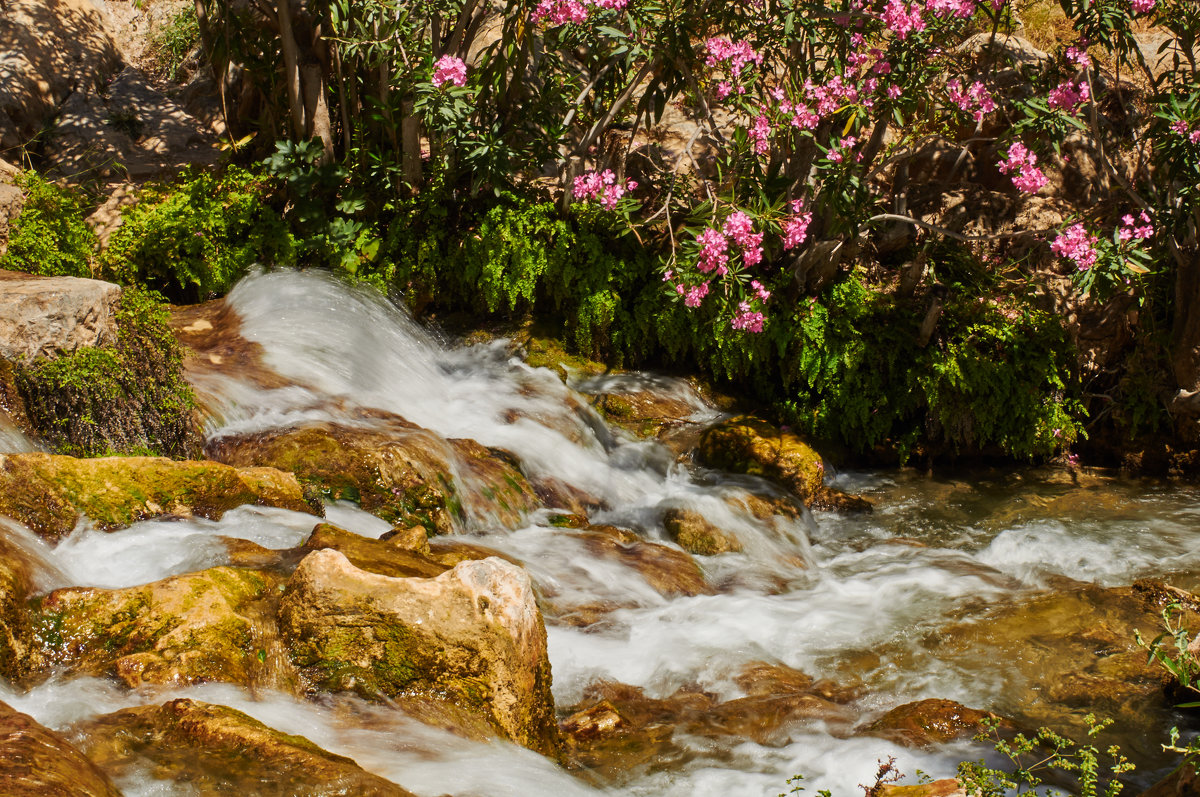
[16,287,198,459]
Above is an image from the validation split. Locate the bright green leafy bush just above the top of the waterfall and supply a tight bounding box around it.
[101,167,296,300]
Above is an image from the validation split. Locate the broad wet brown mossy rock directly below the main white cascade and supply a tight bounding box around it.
[208,417,536,533]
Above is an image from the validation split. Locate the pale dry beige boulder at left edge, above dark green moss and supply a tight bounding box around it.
[0,271,121,360]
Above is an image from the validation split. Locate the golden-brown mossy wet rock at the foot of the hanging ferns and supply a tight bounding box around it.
[700,415,870,511]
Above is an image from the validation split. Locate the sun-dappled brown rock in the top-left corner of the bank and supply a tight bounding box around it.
[0,0,120,151]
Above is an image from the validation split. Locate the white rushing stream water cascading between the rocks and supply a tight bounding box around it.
[0,272,1200,797]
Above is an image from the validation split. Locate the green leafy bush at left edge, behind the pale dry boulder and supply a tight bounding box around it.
[0,172,96,277]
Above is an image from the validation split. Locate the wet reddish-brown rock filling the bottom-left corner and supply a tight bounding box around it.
[0,703,121,797]
